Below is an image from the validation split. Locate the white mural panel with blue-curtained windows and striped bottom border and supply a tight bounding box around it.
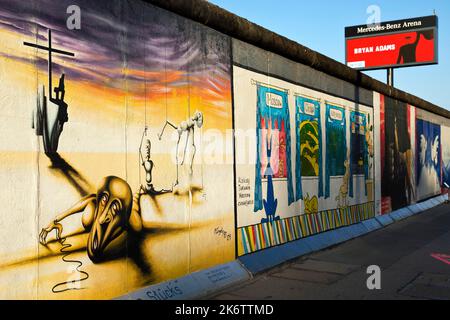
[233,66,375,255]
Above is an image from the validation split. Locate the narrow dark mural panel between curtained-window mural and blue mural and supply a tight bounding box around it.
[380,95,416,213]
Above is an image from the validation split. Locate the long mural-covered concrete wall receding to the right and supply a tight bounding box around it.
[0,0,450,299]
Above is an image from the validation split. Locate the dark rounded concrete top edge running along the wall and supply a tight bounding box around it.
[144,0,450,119]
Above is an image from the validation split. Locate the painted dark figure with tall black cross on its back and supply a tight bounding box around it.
[23,29,75,157]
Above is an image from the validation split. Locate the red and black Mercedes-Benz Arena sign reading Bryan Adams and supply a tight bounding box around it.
[345,16,438,70]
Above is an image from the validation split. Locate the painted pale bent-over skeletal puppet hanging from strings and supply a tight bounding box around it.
[158,111,203,186]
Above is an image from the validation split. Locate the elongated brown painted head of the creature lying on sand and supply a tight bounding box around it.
[87,176,133,262]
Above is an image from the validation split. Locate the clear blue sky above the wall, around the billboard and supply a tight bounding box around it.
[210,0,450,110]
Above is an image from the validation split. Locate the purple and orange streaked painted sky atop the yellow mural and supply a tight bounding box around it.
[0,0,230,97]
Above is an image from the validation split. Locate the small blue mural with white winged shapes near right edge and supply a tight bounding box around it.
[416,119,441,200]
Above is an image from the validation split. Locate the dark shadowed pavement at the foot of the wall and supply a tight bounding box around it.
[206,204,450,300]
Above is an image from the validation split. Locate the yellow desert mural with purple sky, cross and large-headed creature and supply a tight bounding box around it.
[0,0,234,299]
